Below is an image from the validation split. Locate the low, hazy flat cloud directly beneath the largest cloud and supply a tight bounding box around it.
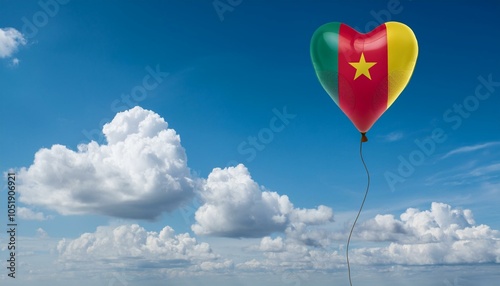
[57,224,227,271]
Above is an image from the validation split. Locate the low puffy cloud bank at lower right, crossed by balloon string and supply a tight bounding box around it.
[240,203,500,271]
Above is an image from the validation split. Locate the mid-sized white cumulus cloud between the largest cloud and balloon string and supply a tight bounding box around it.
[191,164,333,237]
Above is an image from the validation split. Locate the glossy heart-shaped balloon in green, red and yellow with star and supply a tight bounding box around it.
[311,22,418,137]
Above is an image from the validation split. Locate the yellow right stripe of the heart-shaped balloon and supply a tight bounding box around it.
[385,22,418,108]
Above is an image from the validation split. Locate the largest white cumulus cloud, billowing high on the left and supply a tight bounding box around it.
[19,107,196,219]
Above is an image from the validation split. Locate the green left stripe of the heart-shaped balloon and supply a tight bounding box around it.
[311,22,341,106]
